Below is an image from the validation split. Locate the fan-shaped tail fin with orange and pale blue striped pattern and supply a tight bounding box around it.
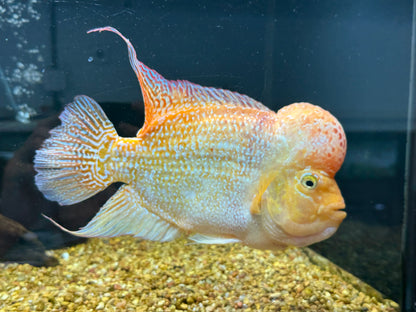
[34,95,118,205]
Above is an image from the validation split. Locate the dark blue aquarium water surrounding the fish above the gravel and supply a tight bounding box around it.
[0,0,414,311]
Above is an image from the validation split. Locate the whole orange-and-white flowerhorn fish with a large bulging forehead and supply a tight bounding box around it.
[34,27,346,249]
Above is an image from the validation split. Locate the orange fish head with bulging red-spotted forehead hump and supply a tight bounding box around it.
[261,103,346,246]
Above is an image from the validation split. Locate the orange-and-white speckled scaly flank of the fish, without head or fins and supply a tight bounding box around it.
[112,106,274,234]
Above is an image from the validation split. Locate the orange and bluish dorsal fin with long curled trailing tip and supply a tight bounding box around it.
[88,26,270,134]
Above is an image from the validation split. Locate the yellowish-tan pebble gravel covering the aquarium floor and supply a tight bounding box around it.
[0,237,399,312]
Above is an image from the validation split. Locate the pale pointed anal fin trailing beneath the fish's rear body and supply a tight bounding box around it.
[47,185,181,242]
